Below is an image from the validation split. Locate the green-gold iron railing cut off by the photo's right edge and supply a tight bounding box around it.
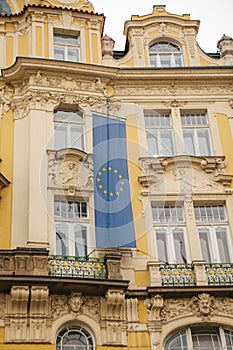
[205,263,233,286]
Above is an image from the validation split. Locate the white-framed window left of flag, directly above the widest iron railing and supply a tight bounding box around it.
[54,199,88,256]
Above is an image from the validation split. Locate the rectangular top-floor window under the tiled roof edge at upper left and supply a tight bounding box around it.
[53,33,80,62]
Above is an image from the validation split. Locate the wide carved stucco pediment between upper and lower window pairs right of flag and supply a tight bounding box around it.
[139,156,232,193]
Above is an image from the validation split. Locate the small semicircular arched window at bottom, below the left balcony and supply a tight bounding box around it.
[56,325,95,350]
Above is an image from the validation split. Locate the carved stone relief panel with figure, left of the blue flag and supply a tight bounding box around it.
[48,149,93,195]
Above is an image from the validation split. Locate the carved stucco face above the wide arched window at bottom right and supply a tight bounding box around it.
[191,293,215,320]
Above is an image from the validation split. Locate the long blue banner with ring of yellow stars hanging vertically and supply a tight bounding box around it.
[93,114,136,248]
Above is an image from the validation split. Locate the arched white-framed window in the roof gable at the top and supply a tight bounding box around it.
[149,42,182,67]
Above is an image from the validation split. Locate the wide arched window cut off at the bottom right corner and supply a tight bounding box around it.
[164,326,233,350]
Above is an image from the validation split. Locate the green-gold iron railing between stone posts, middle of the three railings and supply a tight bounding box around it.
[160,264,195,287]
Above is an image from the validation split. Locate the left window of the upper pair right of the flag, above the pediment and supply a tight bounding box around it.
[145,111,174,156]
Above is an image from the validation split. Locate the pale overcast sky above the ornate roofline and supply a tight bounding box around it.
[90,0,233,52]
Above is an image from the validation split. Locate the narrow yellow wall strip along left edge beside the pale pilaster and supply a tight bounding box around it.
[0,110,14,249]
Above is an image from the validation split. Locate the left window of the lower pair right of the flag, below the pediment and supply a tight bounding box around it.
[152,204,189,264]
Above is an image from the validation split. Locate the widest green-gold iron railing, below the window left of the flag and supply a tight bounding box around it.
[48,255,106,279]
